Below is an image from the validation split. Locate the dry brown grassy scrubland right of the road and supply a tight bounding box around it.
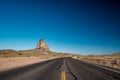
[76,53,120,69]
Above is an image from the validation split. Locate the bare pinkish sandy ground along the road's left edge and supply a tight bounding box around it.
[0,57,46,71]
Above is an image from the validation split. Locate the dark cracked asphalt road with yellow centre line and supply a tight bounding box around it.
[0,58,120,80]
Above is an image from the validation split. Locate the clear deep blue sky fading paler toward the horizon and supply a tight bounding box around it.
[0,0,120,54]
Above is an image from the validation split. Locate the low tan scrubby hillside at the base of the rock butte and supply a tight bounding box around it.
[0,49,73,58]
